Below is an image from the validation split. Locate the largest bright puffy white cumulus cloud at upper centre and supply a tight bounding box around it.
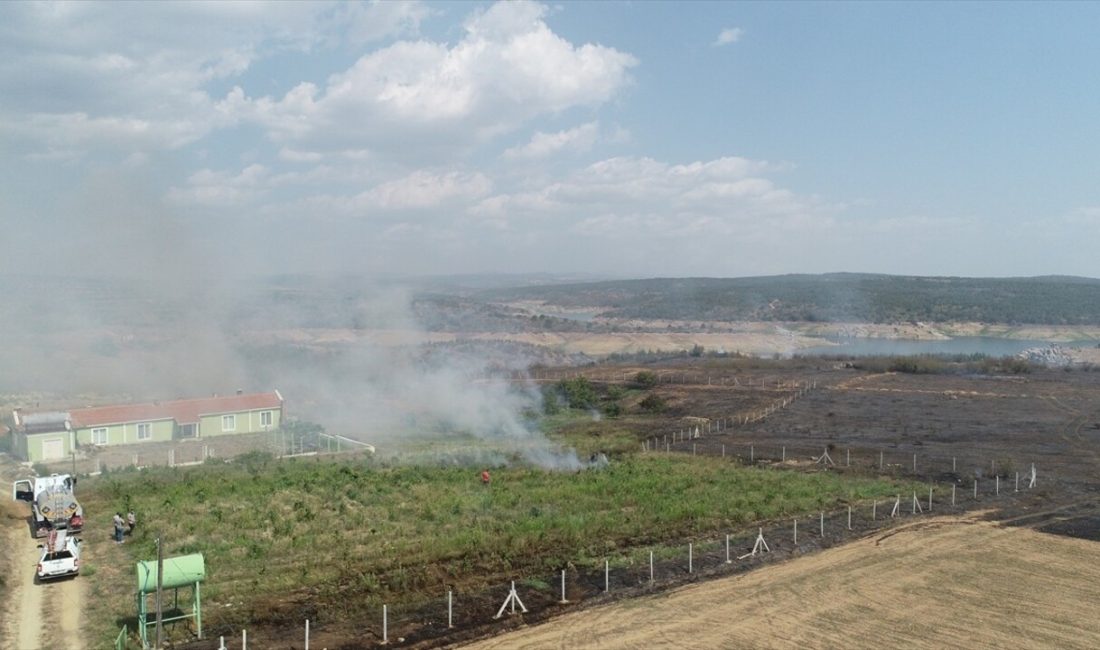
[238,2,637,153]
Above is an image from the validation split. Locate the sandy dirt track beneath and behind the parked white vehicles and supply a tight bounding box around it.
[0,514,85,650]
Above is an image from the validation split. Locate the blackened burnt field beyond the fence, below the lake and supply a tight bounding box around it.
[563,359,1100,540]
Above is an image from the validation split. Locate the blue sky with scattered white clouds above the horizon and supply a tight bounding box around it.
[0,1,1100,277]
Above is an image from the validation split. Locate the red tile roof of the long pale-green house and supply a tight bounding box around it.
[69,390,283,429]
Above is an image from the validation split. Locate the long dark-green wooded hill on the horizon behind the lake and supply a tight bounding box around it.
[477,273,1100,326]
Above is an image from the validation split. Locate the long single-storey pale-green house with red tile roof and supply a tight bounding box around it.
[12,390,284,462]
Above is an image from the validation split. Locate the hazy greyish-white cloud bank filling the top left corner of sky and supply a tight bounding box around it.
[0,2,398,159]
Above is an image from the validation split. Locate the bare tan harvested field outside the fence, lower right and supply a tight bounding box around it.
[470,517,1100,649]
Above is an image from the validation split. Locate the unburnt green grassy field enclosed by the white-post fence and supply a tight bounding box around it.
[80,454,926,642]
